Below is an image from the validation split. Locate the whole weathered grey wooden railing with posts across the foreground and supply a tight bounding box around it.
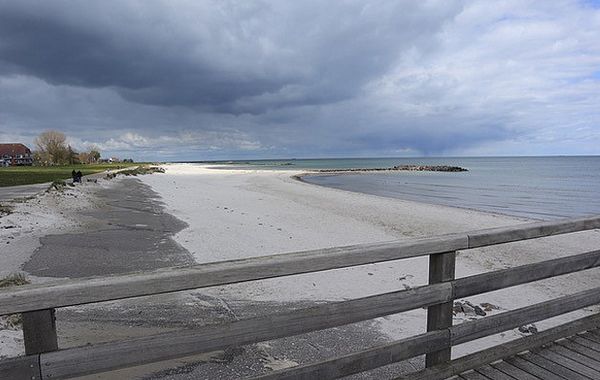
[0,217,600,379]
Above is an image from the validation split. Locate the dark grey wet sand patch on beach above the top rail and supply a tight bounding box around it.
[23,178,194,278]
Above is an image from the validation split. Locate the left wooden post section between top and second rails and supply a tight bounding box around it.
[22,309,58,355]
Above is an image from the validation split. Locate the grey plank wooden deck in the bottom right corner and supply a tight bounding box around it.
[449,329,600,380]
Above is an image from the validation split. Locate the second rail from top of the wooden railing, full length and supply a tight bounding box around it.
[9,251,600,378]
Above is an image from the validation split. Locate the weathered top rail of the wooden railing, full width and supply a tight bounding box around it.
[0,217,600,315]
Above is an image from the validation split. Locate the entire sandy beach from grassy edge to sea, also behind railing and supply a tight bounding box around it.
[0,164,600,379]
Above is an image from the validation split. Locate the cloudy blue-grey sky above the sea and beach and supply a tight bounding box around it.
[0,0,600,161]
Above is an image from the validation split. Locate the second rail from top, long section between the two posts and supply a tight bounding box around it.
[40,283,452,377]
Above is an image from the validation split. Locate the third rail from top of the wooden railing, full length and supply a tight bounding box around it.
[244,288,600,380]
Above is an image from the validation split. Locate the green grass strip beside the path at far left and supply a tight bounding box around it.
[0,163,139,187]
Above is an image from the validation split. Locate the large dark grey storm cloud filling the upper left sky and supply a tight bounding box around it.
[0,1,460,113]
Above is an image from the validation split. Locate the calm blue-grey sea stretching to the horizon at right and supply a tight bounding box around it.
[196,156,600,220]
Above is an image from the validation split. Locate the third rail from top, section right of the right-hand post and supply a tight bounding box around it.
[450,287,600,345]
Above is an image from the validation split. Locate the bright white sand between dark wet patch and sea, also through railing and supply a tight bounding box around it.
[140,164,600,354]
